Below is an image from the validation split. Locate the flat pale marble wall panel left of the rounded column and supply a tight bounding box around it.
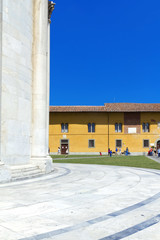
[0,0,33,165]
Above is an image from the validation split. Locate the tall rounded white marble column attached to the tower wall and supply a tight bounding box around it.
[31,0,51,172]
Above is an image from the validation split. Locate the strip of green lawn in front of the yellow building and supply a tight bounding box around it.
[52,155,160,170]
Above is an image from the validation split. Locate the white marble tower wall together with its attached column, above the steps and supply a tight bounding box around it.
[0,0,53,182]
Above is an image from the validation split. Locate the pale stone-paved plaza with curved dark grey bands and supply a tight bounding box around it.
[0,163,160,240]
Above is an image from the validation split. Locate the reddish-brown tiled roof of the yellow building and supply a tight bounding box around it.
[50,103,160,112]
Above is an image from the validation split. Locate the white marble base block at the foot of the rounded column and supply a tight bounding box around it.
[30,156,53,173]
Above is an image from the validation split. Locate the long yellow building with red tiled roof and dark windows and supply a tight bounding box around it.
[49,103,160,154]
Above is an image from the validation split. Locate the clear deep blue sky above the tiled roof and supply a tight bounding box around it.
[50,0,160,105]
